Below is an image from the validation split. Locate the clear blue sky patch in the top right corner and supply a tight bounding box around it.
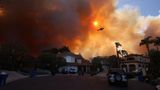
[117,0,160,16]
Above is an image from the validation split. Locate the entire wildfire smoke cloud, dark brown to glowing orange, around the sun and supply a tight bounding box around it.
[0,0,160,59]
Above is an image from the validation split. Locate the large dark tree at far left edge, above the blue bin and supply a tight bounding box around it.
[0,43,27,70]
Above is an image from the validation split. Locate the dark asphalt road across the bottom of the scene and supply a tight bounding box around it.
[1,75,154,90]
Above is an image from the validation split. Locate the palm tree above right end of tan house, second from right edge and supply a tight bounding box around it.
[139,36,153,54]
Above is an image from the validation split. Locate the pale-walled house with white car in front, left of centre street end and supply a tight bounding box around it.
[58,52,91,73]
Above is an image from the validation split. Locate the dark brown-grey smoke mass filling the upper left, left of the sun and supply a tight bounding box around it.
[0,0,91,52]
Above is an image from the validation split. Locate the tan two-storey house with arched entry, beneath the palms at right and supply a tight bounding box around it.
[120,54,150,74]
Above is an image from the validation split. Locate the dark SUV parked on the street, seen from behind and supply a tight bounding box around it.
[107,68,128,87]
